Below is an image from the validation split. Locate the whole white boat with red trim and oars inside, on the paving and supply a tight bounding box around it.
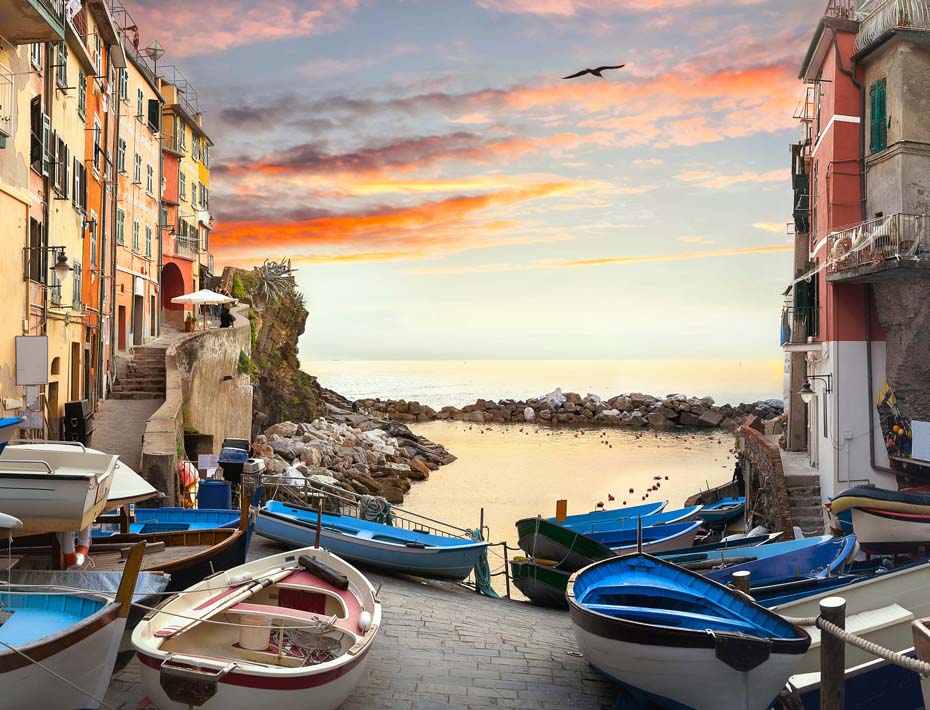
[132,547,381,710]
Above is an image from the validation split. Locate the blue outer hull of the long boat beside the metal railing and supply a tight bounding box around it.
[255,511,487,582]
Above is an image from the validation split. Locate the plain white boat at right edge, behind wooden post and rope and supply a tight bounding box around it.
[772,562,930,673]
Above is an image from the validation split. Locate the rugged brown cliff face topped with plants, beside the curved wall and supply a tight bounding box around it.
[221,267,321,439]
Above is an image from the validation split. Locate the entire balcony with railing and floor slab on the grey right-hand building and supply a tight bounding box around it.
[827,213,930,283]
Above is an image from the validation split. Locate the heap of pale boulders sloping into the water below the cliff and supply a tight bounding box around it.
[253,416,455,503]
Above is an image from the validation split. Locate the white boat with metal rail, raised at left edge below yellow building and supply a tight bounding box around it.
[0,444,118,533]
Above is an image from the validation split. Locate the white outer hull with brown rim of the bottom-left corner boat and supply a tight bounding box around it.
[0,604,126,710]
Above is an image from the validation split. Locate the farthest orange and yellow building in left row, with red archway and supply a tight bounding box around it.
[160,66,213,326]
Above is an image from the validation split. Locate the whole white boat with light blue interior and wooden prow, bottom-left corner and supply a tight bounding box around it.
[0,518,144,710]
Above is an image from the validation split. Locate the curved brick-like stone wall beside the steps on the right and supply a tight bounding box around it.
[739,426,794,540]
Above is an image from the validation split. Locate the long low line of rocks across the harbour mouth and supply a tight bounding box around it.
[355,389,784,434]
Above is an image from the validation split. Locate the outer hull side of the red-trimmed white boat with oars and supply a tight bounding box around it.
[136,647,370,710]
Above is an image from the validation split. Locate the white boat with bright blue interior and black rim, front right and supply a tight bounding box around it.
[566,554,811,710]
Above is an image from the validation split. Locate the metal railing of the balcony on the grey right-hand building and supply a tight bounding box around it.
[827,213,930,274]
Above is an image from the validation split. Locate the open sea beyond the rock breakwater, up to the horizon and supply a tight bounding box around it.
[302,360,784,409]
